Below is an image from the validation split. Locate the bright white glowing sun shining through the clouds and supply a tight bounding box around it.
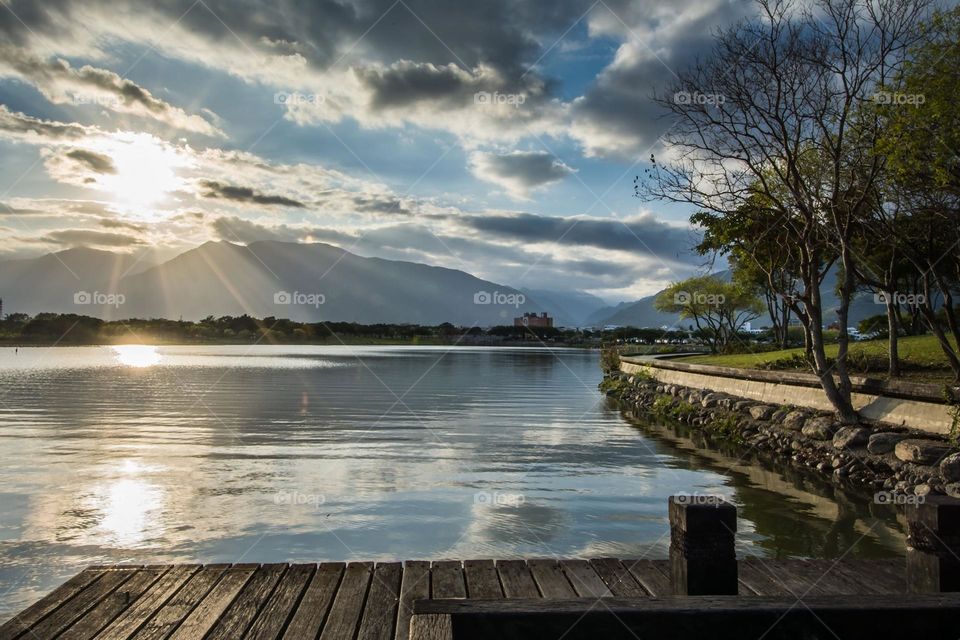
[99,133,189,216]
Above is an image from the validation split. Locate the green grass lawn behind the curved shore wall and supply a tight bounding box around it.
[683,336,953,383]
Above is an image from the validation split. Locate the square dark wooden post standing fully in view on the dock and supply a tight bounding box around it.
[669,495,738,596]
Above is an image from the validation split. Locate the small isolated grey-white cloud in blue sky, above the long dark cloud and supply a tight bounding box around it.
[470,151,576,198]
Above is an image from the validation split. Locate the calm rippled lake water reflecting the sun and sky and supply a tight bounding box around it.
[0,346,903,618]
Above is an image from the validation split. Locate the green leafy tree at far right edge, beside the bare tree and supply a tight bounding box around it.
[877,8,960,380]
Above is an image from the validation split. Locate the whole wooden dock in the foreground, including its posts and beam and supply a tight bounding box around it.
[7,497,960,640]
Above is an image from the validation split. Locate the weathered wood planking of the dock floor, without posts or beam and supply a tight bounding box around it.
[0,558,906,640]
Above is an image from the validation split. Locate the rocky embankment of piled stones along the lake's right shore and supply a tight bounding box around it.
[600,373,960,502]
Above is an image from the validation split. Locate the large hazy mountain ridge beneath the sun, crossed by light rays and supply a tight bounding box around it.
[0,241,542,326]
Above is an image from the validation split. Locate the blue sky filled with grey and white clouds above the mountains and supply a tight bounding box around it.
[0,0,754,302]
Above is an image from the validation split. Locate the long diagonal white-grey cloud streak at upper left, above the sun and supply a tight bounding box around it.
[0,46,226,137]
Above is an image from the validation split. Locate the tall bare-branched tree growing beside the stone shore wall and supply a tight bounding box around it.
[638,0,928,423]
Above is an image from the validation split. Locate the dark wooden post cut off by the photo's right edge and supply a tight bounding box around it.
[906,496,960,593]
